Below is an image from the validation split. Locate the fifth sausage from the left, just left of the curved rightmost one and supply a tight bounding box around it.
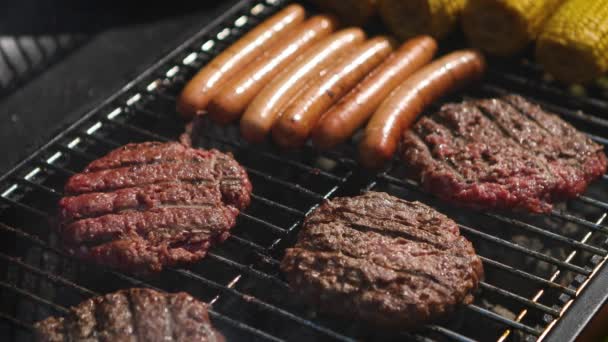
[312,36,437,148]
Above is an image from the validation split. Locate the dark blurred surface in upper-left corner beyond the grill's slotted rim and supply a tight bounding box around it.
[0,0,236,172]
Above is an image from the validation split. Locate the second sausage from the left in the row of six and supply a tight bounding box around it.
[208,15,336,124]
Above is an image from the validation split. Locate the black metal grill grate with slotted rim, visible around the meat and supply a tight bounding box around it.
[0,0,608,341]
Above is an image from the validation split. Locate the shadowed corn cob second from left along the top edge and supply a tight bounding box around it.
[378,0,466,39]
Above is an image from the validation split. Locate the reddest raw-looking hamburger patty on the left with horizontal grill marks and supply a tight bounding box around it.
[59,142,251,273]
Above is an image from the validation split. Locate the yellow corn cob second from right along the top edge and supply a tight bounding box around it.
[462,0,563,56]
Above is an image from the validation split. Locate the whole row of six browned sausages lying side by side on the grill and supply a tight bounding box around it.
[177,4,485,167]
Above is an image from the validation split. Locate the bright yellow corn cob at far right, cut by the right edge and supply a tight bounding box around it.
[536,0,608,83]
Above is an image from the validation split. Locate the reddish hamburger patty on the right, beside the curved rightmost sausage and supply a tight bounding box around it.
[402,95,606,213]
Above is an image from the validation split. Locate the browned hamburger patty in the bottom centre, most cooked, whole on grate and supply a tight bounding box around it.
[281,192,483,329]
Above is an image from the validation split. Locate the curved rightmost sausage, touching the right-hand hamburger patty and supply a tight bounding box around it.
[359,50,485,168]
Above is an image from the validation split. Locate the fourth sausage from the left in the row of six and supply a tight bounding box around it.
[272,37,392,147]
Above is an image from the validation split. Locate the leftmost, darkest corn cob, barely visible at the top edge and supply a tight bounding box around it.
[311,0,377,26]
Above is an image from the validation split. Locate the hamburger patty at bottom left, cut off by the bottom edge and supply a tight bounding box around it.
[35,288,224,342]
